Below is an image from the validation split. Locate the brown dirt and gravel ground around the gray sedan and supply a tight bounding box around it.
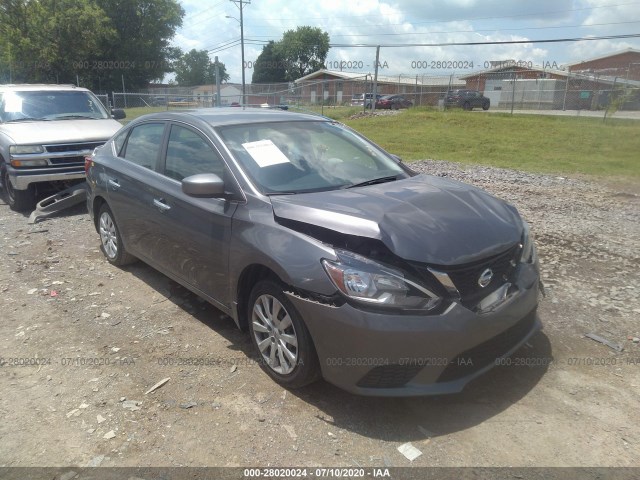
[0,161,640,467]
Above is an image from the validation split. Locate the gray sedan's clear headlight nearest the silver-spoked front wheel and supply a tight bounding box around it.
[322,250,440,310]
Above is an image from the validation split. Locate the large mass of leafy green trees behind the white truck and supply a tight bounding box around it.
[0,0,184,91]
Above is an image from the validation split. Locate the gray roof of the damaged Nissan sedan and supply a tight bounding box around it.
[130,107,331,127]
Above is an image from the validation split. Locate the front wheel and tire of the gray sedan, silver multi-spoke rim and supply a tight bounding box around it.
[247,280,320,388]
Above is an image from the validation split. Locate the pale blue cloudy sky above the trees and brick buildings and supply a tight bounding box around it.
[173,0,640,83]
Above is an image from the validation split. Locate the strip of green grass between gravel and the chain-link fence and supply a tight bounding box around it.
[336,108,640,179]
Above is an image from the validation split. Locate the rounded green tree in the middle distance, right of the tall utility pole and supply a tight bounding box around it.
[275,26,329,81]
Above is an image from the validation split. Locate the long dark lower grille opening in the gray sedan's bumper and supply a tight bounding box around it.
[437,310,536,382]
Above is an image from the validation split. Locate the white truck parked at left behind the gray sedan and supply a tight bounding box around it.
[0,85,125,211]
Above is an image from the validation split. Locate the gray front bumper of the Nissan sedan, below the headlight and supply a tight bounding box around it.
[289,264,542,396]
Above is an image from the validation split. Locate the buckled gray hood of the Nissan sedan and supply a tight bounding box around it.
[271,175,522,265]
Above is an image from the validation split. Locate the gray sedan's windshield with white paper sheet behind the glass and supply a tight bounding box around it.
[218,121,408,194]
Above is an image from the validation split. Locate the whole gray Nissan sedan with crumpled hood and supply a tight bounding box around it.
[86,108,541,396]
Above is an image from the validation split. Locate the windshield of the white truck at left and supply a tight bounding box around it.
[0,90,109,122]
